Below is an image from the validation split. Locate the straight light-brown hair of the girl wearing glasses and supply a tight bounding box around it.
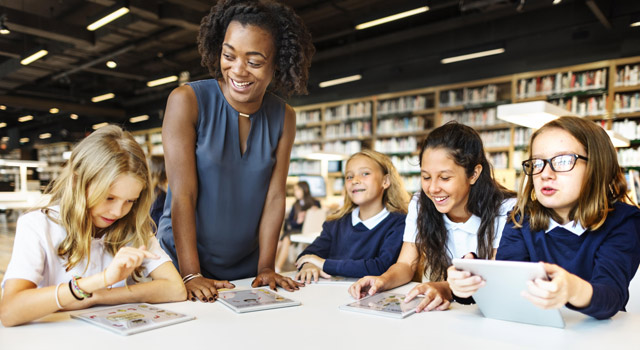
[510,117,631,231]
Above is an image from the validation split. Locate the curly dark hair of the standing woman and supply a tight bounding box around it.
[198,0,315,97]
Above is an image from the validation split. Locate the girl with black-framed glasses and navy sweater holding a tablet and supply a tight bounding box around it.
[449,117,640,319]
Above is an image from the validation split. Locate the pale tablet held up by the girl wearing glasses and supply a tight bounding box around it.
[453,259,564,328]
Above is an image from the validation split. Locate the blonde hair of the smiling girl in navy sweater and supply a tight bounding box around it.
[327,149,410,220]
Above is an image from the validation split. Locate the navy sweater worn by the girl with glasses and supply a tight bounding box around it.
[496,203,640,319]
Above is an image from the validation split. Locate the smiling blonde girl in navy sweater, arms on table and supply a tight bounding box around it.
[296,150,409,283]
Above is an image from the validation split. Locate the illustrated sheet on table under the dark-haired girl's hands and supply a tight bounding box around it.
[340,292,424,318]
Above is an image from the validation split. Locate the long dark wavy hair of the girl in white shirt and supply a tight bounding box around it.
[416,121,515,281]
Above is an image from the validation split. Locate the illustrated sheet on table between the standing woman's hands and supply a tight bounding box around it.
[218,288,300,313]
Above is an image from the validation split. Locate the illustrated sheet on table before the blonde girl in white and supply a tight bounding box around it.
[71,303,195,335]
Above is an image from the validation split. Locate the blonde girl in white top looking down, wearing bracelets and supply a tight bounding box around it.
[0,126,186,326]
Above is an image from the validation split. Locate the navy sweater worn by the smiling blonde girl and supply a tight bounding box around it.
[298,213,406,278]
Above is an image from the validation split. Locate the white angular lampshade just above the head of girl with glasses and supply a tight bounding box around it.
[498,101,578,129]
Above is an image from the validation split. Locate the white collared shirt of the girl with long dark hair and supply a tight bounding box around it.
[403,192,516,259]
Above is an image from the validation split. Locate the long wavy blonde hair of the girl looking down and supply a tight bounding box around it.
[40,125,152,275]
